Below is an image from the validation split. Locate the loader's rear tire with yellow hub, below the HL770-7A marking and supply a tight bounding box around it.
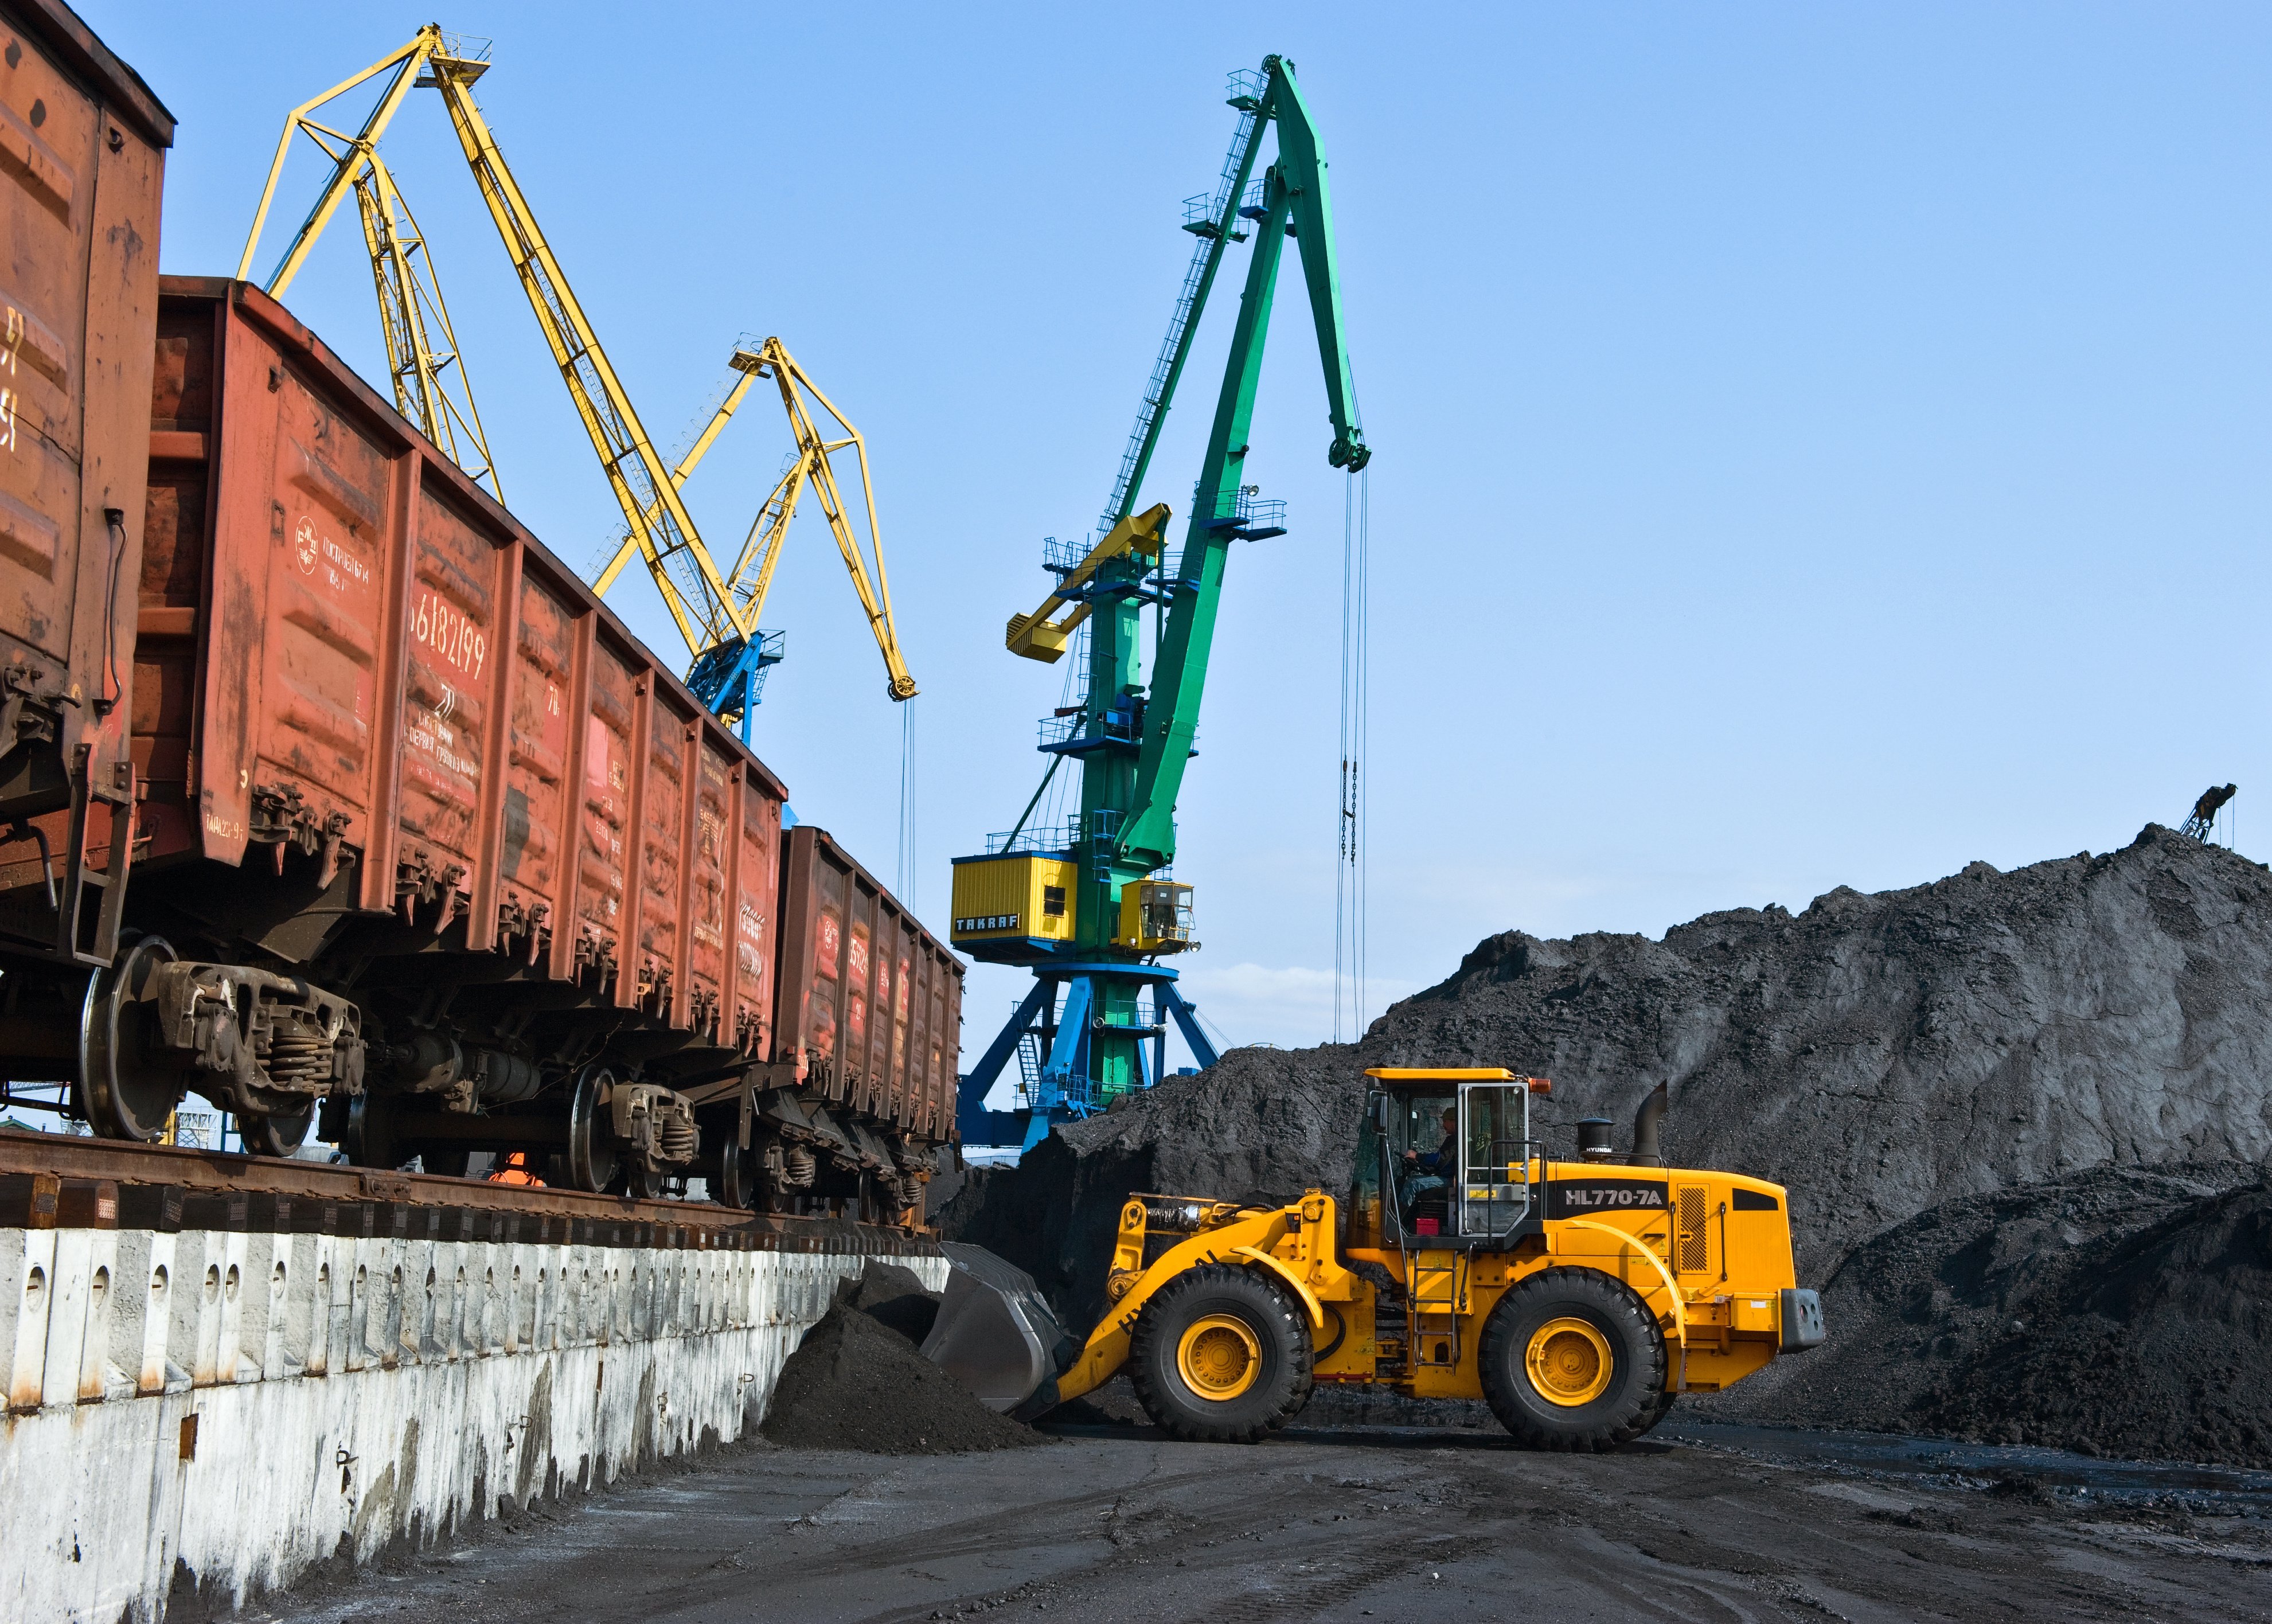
[1479,1270,1665,1451]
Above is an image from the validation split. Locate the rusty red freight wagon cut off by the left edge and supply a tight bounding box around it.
[0,0,173,965]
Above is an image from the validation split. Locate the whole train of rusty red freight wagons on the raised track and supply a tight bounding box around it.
[0,0,963,1222]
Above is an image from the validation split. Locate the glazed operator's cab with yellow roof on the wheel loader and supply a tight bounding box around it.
[1347,1065,1552,1249]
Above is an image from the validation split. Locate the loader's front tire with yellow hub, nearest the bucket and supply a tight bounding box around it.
[1129,1263,1311,1445]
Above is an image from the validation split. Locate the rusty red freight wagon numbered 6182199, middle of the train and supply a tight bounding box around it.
[0,277,959,1217]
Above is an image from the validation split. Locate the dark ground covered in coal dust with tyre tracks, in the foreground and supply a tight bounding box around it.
[243,1415,2272,1624]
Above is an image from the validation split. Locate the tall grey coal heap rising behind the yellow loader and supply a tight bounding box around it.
[940,825,2272,1462]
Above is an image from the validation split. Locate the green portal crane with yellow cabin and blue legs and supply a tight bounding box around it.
[952,57,1372,1142]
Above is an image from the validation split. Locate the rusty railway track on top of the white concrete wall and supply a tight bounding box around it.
[0,1129,936,1256]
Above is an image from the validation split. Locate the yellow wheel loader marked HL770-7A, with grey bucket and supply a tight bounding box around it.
[925,1068,1822,1449]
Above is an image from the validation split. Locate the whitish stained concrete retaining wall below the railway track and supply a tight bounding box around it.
[0,1229,945,1624]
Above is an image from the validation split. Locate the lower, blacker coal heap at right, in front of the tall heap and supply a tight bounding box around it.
[1754,1163,2272,1465]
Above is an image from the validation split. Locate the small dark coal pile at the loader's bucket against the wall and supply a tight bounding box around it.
[759,1263,1043,1456]
